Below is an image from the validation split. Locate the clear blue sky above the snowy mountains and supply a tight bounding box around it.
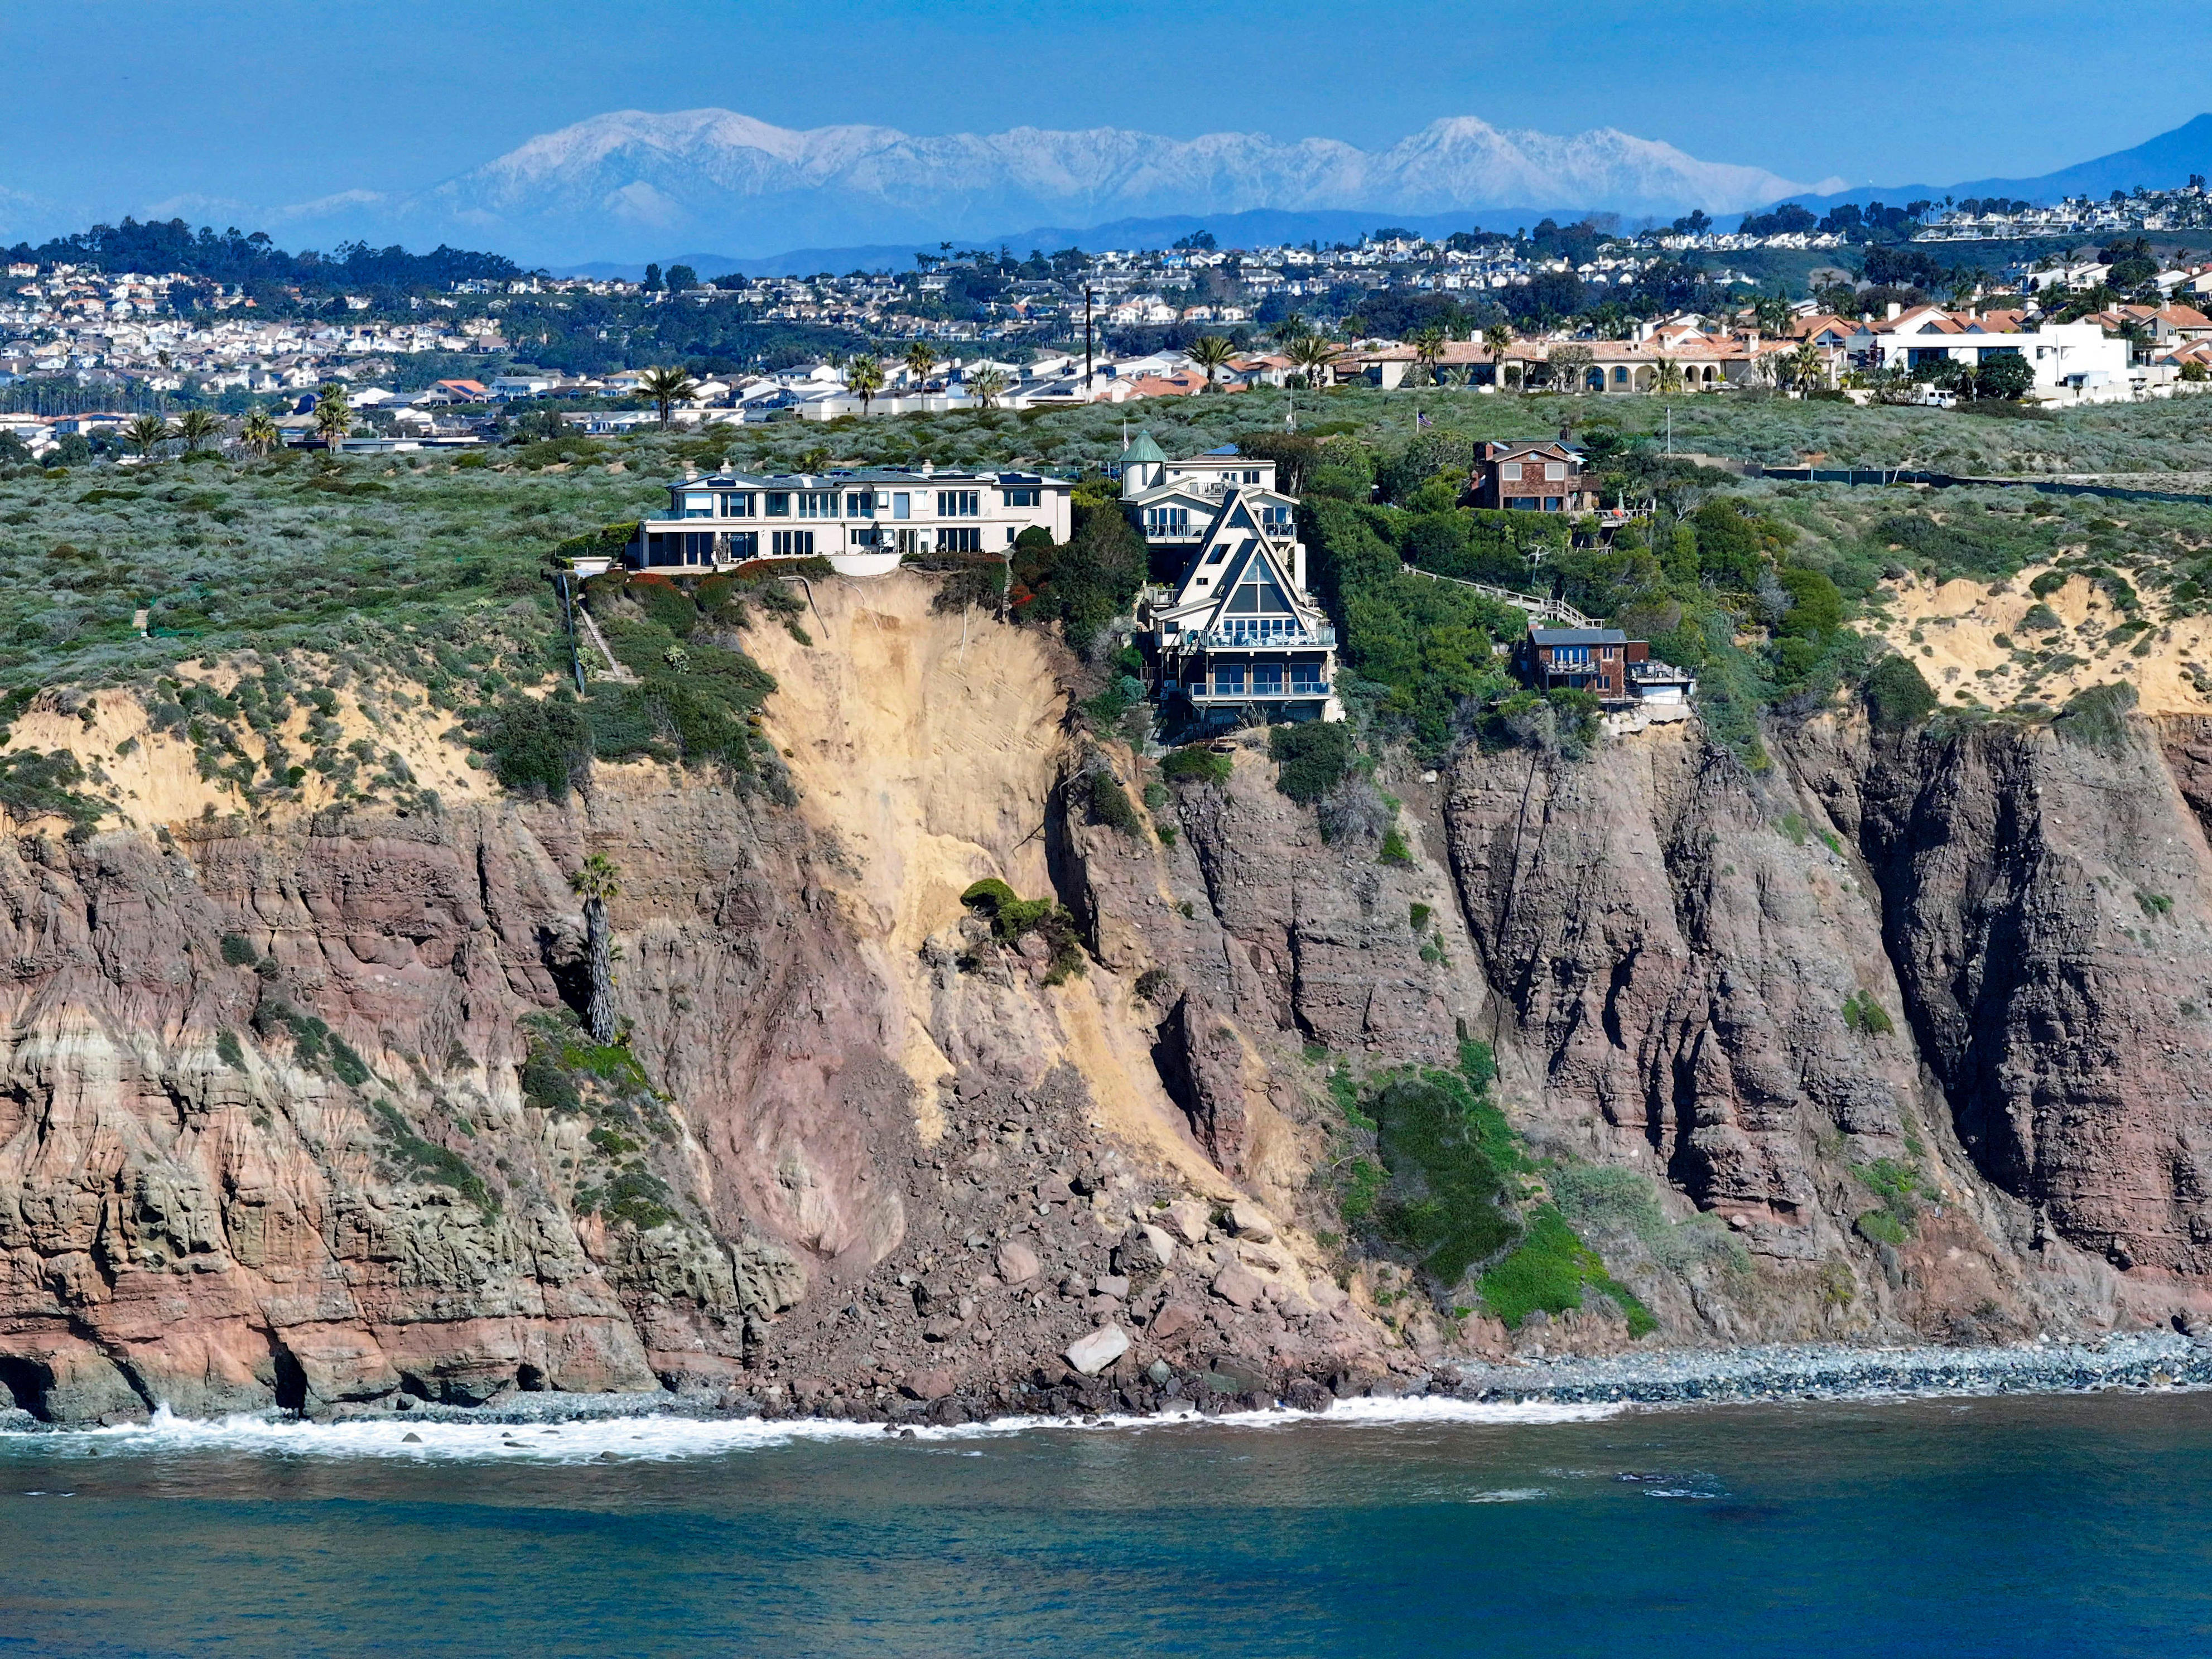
[0,0,2212,232]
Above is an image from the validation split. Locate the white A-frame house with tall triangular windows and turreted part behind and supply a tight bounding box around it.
[1121,431,1343,728]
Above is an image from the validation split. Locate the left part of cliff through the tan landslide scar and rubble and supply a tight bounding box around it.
[0,577,1418,1422]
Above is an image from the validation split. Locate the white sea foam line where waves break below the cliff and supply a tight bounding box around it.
[0,1400,1626,1464]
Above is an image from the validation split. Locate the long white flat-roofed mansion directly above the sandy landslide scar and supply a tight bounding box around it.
[628,460,1075,575]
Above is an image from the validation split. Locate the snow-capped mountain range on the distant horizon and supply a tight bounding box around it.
[316,108,1807,259]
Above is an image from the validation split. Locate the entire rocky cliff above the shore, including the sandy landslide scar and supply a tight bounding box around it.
[13,577,2212,1422]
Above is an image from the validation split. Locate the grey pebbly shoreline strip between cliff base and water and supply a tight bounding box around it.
[0,1332,2212,1434]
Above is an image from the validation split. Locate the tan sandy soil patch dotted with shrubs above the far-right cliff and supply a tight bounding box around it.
[1867,566,2212,715]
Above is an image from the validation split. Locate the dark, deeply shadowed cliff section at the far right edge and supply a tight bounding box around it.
[1799,721,2212,1303]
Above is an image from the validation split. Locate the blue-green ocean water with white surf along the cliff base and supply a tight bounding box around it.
[0,1393,2212,1659]
